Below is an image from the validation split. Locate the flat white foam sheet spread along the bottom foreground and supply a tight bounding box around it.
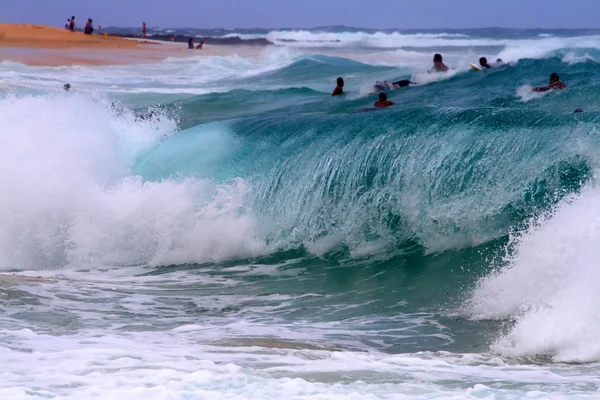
[0,326,599,400]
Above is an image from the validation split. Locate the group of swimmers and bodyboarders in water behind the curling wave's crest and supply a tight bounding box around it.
[331,54,568,112]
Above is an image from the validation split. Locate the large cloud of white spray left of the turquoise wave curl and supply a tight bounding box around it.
[0,93,261,269]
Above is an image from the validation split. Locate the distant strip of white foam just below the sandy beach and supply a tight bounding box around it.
[0,48,302,94]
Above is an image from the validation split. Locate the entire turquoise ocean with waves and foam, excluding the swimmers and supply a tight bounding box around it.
[0,27,600,400]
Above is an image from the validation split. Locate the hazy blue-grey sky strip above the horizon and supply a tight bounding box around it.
[0,0,600,28]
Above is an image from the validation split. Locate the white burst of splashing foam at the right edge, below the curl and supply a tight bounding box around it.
[470,187,600,362]
